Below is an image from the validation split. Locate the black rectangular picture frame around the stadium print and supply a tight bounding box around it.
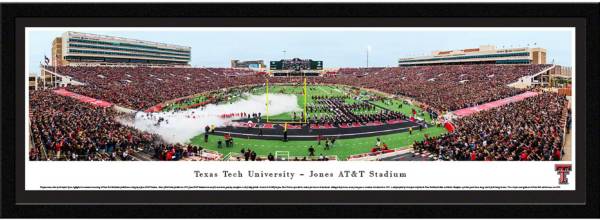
[0,3,600,218]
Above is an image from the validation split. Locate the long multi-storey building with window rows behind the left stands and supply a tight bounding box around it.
[52,31,191,66]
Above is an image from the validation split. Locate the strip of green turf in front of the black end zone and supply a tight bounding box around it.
[191,127,446,160]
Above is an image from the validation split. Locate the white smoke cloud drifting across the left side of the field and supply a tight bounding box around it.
[119,93,301,143]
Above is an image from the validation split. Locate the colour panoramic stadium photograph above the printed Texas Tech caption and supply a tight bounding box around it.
[26,28,575,161]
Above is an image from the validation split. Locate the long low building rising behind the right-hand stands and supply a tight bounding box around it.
[398,45,546,66]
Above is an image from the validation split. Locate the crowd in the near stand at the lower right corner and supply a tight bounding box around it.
[413,93,568,161]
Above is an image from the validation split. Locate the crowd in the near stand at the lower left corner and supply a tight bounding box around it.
[29,90,211,161]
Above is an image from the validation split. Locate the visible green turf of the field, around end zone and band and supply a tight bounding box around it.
[190,85,446,160]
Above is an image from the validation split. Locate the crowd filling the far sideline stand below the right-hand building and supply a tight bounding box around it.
[323,65,550,111]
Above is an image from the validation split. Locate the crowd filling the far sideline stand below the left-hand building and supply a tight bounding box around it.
[58,67,264,110]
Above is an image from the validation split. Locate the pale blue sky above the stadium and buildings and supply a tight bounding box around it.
[27,28,574,73]
